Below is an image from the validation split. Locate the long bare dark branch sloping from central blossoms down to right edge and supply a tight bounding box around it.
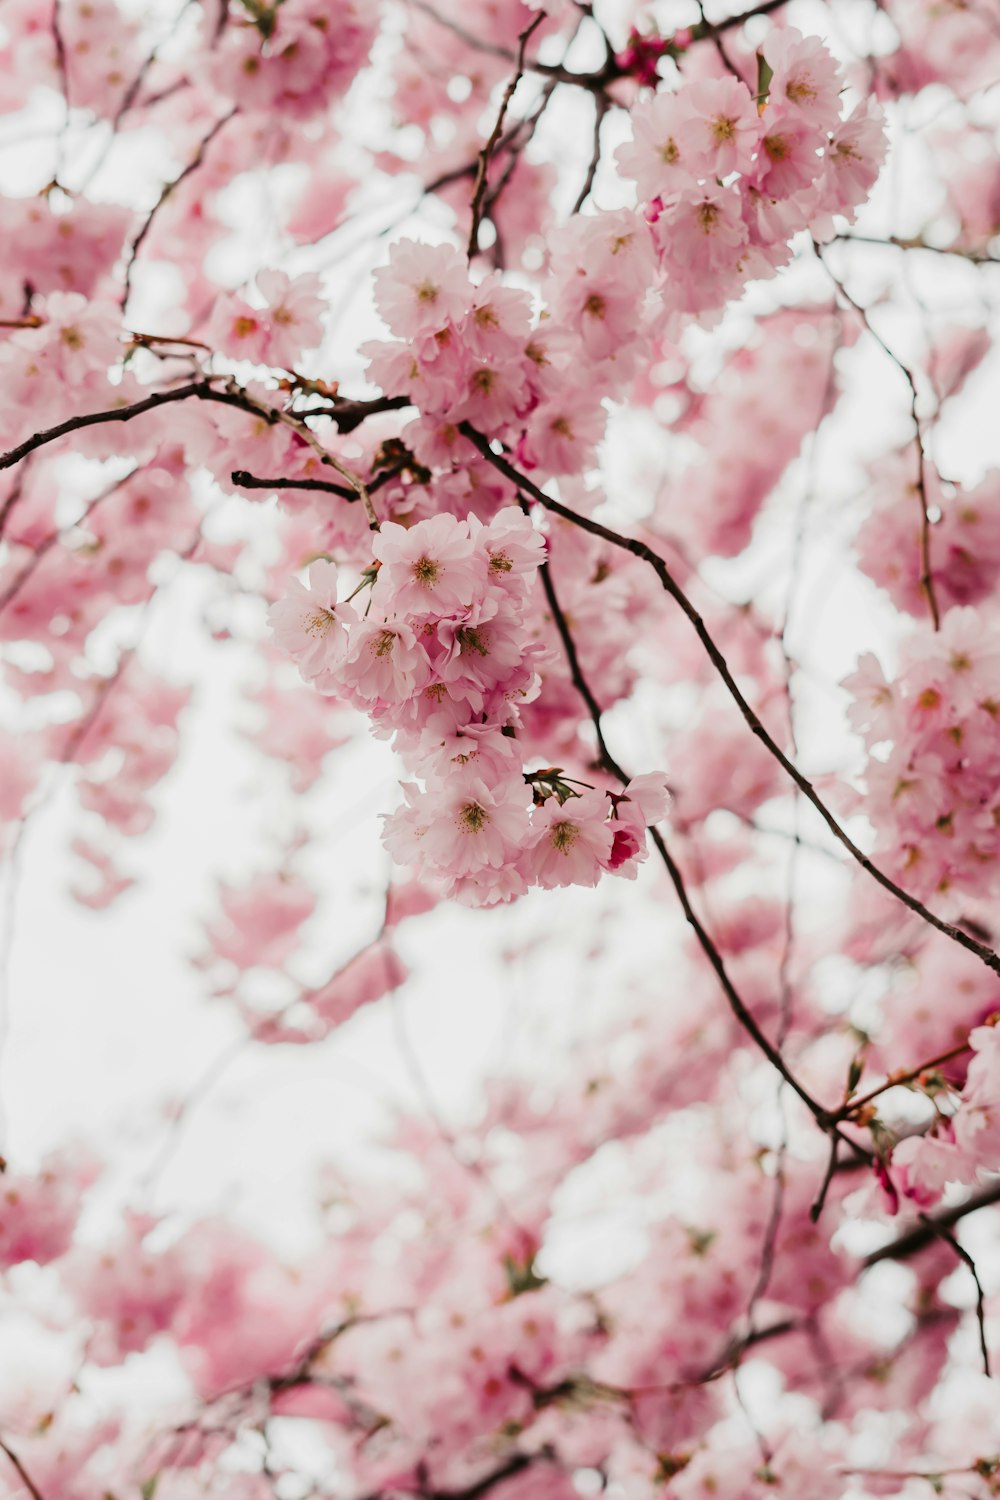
[459,422,1000,974]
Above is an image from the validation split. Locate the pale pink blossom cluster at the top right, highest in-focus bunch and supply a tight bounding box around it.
[616,27,885,314]
